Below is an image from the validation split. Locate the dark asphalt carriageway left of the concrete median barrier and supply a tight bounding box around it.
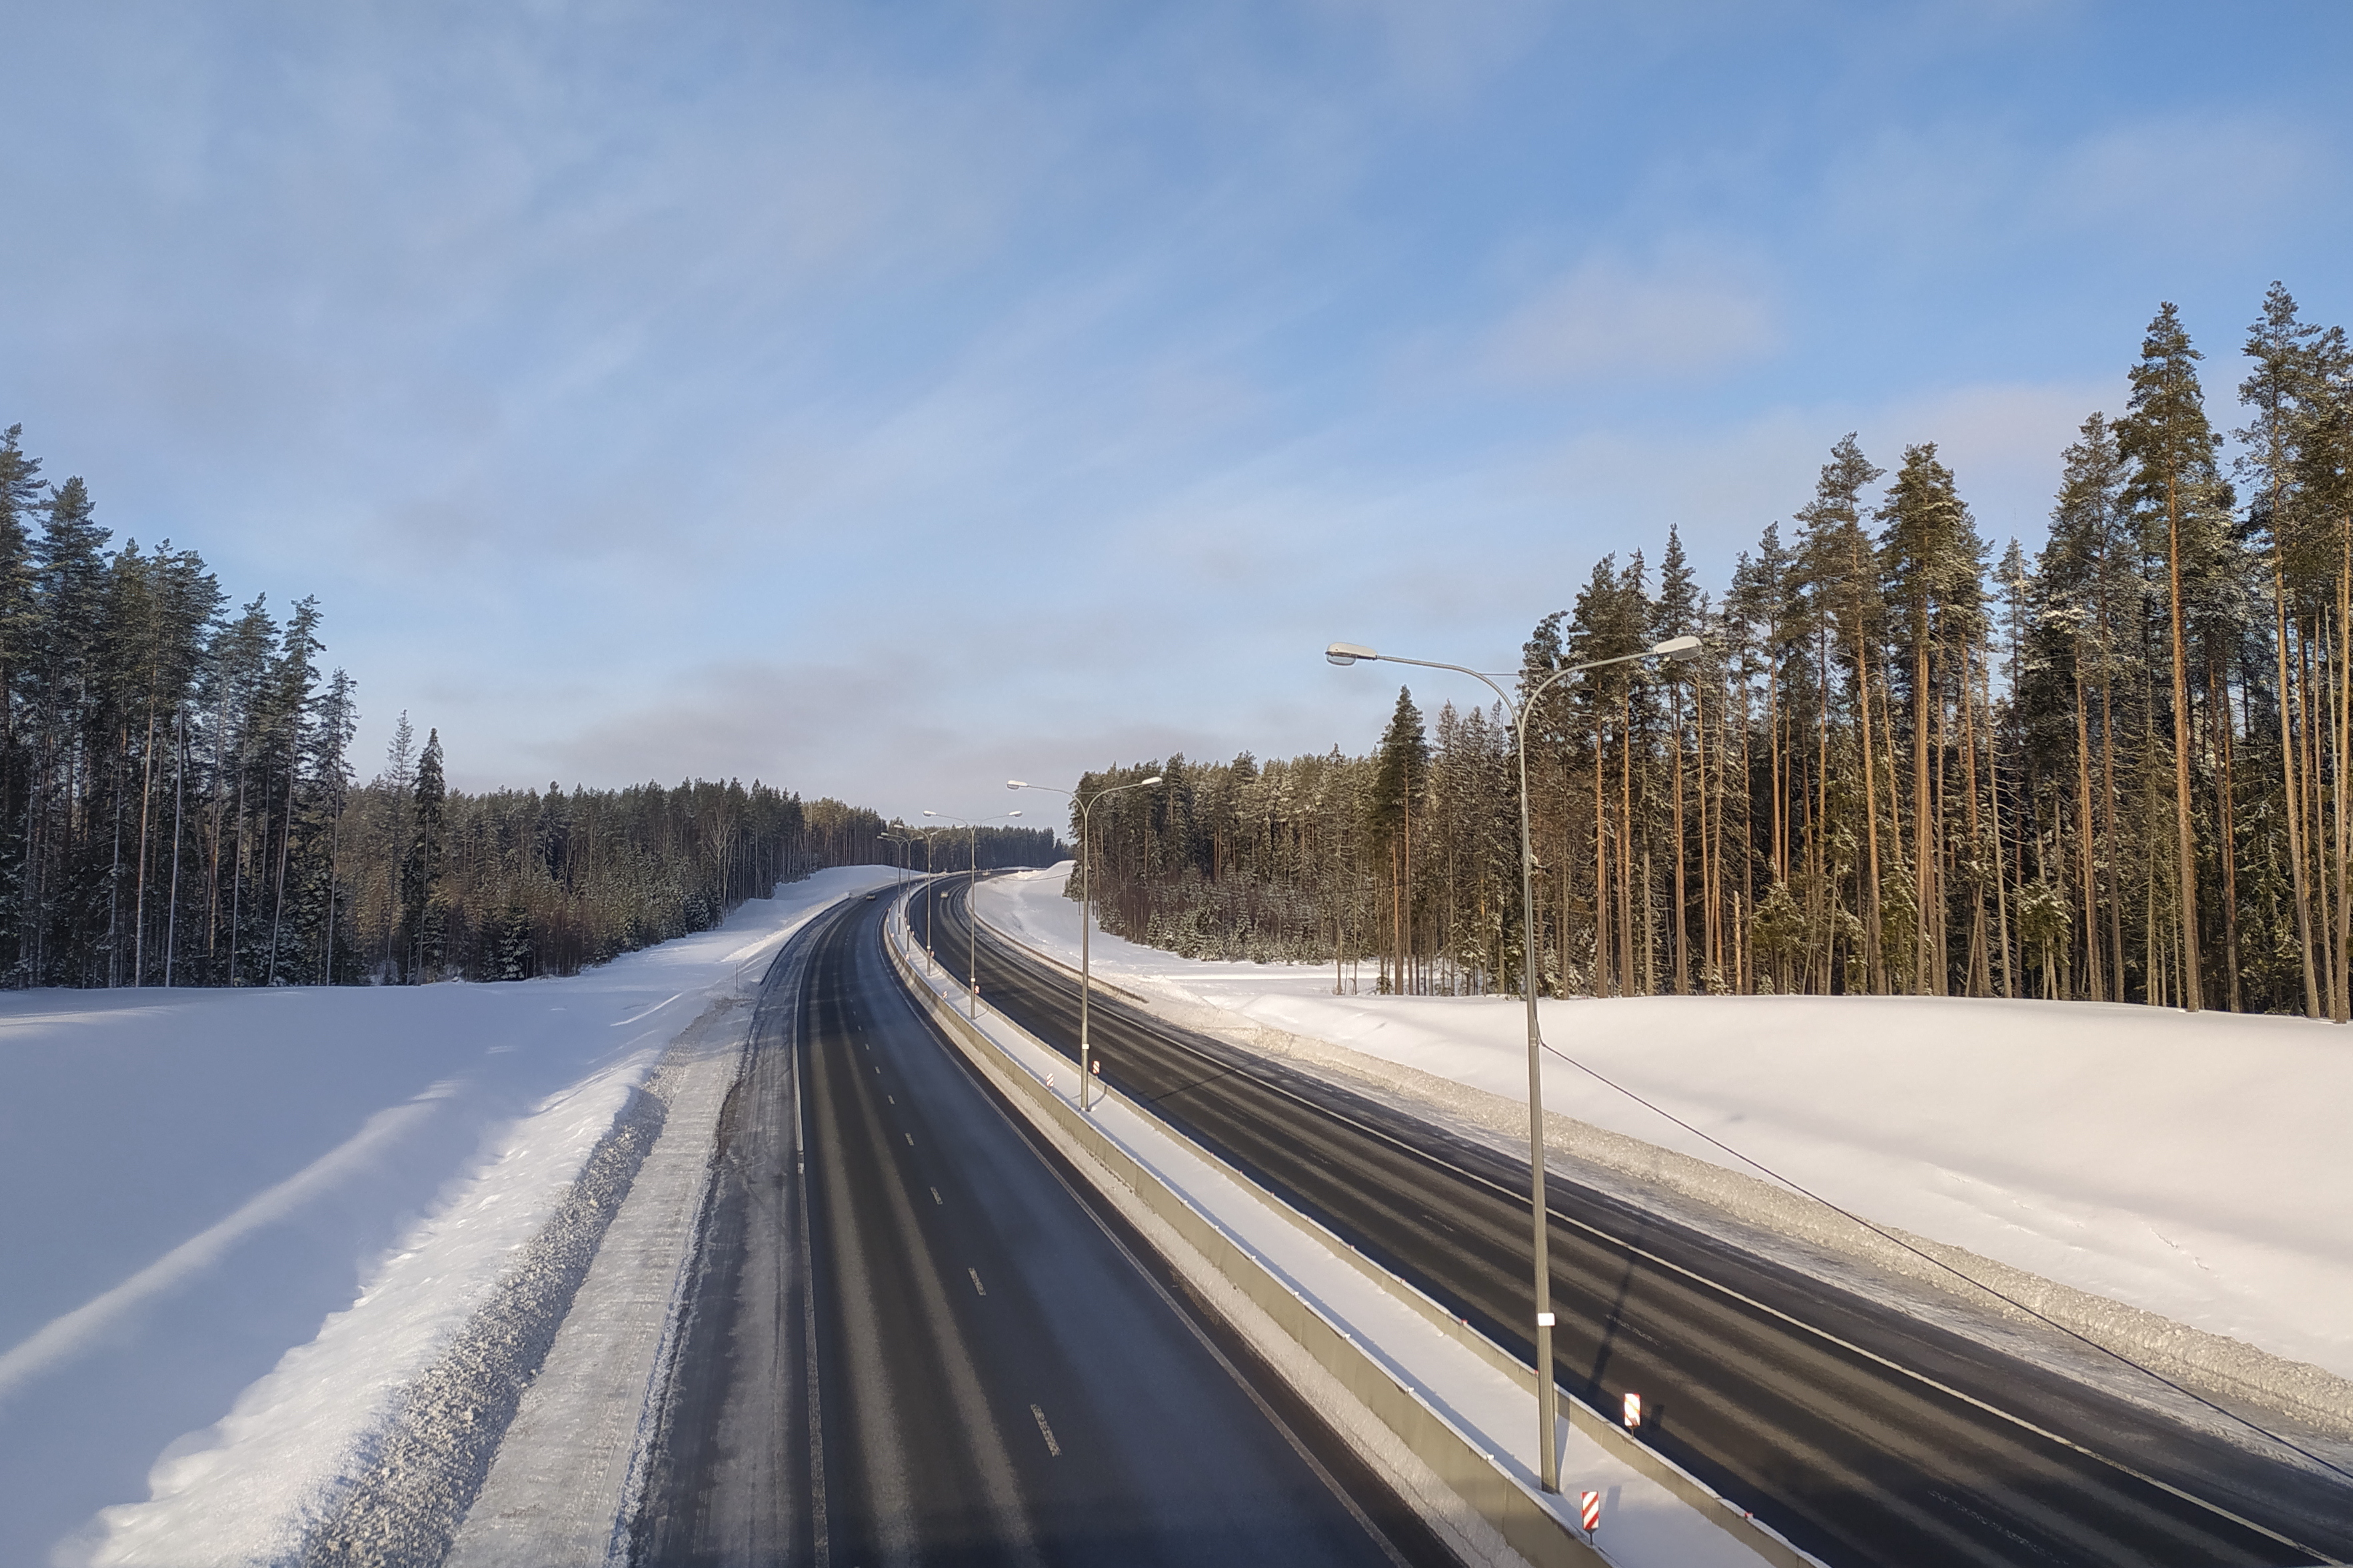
[633,900,1452,1568]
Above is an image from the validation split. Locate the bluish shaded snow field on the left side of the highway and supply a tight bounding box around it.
[0,868,894,1563]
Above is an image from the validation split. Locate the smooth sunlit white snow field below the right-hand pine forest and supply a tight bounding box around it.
[979,863,2353,1377]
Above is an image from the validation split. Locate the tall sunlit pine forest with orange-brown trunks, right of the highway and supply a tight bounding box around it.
[1080,285,2353,1020]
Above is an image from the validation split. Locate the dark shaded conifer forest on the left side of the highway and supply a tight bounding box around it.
[0,426,1057,988]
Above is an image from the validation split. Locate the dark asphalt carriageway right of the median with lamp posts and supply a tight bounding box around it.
[915,879,2353,1568]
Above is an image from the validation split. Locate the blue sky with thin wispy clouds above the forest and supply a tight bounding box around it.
[0,0,2353,814]
